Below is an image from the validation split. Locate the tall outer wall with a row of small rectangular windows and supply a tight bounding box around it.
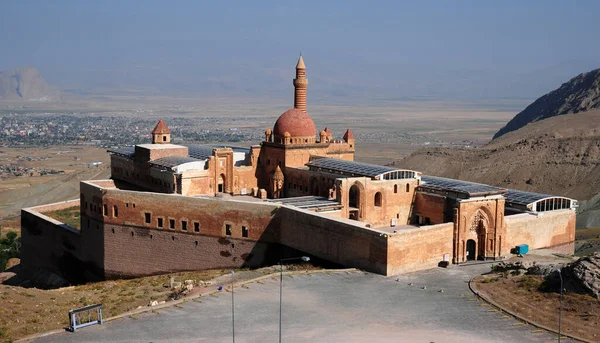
[81,181,280,278]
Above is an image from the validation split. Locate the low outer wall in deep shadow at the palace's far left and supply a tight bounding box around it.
[21,200,85,280]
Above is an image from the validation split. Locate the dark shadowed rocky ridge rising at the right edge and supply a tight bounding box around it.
[494,69,600,139]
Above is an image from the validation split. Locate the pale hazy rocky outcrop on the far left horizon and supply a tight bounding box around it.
[0,67,60,101]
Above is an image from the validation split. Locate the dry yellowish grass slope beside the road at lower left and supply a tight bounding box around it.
[0,270,229,342]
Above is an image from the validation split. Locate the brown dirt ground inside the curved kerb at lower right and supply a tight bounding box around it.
[473,274,600,342]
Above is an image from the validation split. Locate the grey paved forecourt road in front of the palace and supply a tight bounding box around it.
[38,265,567,343]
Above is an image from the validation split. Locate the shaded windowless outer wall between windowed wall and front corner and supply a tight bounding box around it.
[277,207,387,275]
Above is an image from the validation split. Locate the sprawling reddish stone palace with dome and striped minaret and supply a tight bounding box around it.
[21,57,576,280]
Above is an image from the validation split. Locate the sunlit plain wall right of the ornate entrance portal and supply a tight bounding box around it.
[503,210,576,254]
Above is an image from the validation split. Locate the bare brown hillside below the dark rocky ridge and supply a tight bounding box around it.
[395,110,600,227]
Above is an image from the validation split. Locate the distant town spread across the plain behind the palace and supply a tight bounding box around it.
[0,112,262,147]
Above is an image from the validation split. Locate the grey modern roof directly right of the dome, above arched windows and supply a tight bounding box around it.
[306,157,416,179]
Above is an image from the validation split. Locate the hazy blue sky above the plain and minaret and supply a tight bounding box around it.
[0,0,600,99]
